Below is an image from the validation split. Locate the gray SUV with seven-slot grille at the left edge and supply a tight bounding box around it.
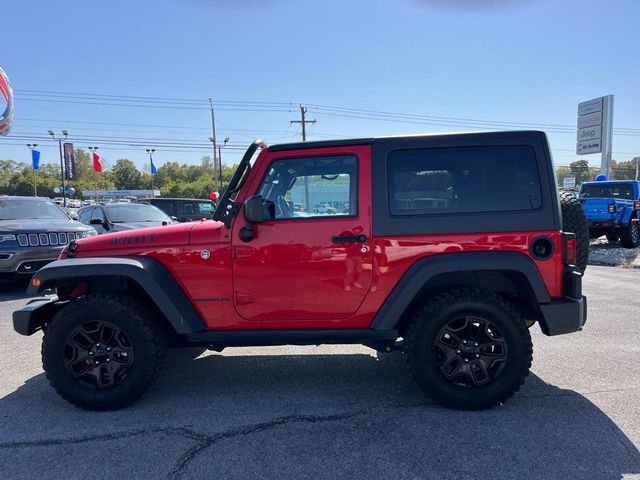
[0,195,96,281]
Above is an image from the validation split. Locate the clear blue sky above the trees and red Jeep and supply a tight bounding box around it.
[0,0,640,172]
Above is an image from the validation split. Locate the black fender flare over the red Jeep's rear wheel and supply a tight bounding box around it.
[371,252,551,330]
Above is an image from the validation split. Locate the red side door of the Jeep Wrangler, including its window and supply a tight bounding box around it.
[232,146,372,328]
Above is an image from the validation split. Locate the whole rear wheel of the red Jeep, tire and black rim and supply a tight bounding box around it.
[404,288,533,410]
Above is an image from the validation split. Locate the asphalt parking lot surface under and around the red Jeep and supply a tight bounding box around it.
[0,266,640,479]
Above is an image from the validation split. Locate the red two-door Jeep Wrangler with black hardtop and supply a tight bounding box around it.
[13,131,586,410]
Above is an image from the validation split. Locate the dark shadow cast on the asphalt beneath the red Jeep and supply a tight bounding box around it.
[0,349,640,479]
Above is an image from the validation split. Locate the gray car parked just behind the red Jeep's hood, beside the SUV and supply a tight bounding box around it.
[78,203,177,234]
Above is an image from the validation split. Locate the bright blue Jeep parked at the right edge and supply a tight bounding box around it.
[579,180,640,248]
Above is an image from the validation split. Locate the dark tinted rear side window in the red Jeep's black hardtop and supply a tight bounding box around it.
[387,146,542,215]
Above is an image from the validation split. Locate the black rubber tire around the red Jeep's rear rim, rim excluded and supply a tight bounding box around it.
[404,288,533,410]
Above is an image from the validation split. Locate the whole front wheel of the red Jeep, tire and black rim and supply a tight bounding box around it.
[42,293,167,410]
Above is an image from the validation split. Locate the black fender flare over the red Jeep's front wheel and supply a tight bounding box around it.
[27,257,206,334]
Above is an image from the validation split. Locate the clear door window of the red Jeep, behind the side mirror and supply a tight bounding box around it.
[258,155,358,219]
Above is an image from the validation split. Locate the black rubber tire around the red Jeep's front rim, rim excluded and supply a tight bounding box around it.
[42,293,167,410]
